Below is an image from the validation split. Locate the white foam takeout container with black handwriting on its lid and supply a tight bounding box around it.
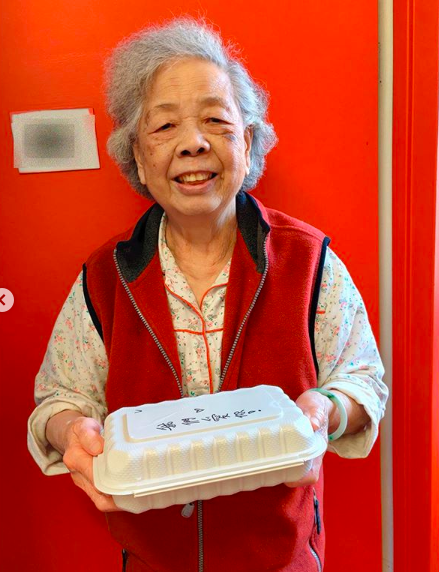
[93,385,326,513]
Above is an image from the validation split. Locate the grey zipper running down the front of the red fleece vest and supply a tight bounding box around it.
[113,235,268,572]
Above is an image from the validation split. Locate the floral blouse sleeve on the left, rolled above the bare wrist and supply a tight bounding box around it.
[28,272,108,475]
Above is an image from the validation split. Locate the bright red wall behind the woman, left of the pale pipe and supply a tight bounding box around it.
[0,0,381,572]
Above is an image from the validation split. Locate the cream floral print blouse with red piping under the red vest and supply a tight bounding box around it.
[28,215,388,475]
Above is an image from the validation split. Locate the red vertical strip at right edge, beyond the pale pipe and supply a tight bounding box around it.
[393,0,439,572]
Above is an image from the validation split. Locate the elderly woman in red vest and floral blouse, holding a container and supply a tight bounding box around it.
[29,18,387,572]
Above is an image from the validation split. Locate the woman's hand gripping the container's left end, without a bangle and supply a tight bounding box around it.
[46,411,121,512]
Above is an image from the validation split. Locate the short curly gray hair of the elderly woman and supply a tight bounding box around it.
[106,17,277,198]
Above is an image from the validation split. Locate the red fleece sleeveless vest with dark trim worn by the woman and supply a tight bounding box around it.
[86,198,324,572]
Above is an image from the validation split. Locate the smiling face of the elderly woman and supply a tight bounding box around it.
[134,58,252,216]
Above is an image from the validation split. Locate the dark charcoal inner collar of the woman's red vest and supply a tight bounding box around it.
[116,192,270,282]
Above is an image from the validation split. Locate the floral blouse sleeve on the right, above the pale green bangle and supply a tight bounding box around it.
[314,249,388,458]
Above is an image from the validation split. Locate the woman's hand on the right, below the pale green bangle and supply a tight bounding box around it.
[285,391,336,487]
